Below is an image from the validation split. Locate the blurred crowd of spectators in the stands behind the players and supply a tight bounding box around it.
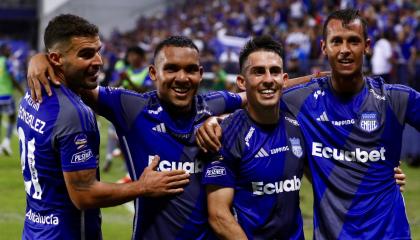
[97,0,420,89]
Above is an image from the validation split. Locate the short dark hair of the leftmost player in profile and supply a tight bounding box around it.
[44,14,99,50]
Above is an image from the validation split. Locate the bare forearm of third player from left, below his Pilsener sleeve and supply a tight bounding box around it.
[206,185,247,240]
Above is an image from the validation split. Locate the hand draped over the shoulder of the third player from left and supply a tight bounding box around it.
[196,117,222,152]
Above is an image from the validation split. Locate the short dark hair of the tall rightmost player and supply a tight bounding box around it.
[322,9,368,40]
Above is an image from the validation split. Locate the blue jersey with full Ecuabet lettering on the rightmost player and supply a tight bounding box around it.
[283,78,420,239]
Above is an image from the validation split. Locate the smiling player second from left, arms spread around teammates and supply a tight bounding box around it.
[28,33,322,239]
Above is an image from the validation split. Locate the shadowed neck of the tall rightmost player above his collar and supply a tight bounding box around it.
[331,73,365,96]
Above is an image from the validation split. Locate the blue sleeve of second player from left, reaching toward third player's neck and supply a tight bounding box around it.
[205,91,242,115]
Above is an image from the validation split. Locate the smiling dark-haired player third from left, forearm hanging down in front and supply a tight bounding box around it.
[203,36,305,239]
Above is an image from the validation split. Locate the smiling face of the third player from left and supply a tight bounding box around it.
[237,50,287,110]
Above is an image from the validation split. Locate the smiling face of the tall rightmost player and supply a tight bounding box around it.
[321,19,370,78]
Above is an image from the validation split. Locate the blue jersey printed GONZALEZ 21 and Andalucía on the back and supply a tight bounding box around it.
[17,86,102,239]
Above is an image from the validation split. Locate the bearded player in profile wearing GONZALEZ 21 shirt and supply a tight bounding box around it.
[17,14,189,239]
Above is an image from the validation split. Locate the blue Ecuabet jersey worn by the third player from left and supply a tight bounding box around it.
[203,110,306,239]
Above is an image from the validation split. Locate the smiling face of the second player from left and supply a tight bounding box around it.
[149,46,203,112]
